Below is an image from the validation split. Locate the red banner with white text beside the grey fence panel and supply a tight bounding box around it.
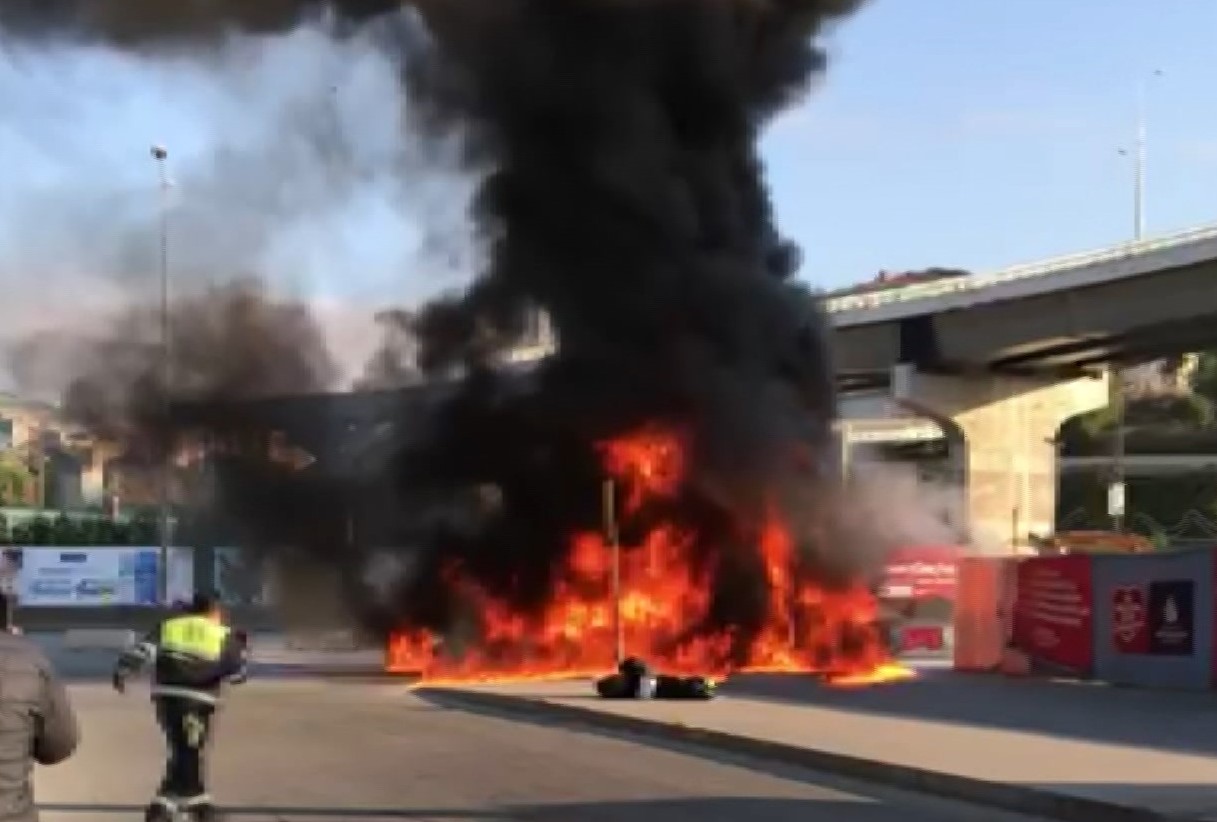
[1014,554,1094,673]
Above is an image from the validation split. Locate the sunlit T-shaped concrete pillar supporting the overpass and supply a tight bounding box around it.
[892,364,1109,550]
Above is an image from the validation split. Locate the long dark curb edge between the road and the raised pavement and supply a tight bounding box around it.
[419,688,1202,822]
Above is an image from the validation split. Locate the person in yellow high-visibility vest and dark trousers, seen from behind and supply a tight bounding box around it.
[113,594,248,822]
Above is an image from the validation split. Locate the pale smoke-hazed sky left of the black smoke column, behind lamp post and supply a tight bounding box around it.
[0,11,472,398]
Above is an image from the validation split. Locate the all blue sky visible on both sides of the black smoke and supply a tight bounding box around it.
[0,0,1217,321]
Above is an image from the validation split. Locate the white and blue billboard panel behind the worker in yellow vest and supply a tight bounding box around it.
[17,547,161,608]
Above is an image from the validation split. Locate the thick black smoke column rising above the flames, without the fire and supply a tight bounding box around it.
[0,0,876,662]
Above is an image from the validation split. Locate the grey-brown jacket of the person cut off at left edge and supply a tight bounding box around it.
[0,628,80,822]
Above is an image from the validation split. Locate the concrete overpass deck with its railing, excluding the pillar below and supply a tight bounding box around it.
[825,219,1217,379]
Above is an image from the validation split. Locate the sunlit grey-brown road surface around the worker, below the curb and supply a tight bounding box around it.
[37,677,1066,822]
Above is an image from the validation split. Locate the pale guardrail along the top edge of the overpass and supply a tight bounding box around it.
[824,225,1217,313]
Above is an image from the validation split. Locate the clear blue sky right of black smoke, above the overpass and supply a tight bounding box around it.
[765,0,1217,287]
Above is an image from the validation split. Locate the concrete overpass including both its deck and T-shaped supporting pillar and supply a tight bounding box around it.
[825,225,1217,550]
